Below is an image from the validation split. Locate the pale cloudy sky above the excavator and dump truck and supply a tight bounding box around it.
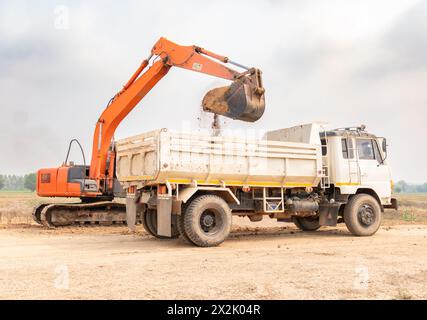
[0,0,427,183]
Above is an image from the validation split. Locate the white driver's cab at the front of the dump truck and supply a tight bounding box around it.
[320,125,393,206]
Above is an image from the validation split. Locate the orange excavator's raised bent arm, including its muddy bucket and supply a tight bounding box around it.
[89,38,265,188]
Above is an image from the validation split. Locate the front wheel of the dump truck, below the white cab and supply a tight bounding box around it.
[344,194,381,236]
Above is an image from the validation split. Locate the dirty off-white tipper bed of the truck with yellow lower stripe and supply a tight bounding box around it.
[116,129,322,187]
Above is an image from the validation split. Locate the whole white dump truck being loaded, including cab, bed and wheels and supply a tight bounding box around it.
[120,123,397,247]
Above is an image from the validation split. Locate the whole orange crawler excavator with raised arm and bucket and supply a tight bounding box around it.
[33,38,265,228]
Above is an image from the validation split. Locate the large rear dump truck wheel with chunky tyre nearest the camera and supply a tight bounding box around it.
[183,195,231,247]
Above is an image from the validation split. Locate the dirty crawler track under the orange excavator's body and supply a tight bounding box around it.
[33,201,139,229]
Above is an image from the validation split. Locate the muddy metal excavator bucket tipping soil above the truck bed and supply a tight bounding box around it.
[202,69,265,122]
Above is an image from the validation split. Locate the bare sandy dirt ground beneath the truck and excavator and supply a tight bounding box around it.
[0,195,427,299]
